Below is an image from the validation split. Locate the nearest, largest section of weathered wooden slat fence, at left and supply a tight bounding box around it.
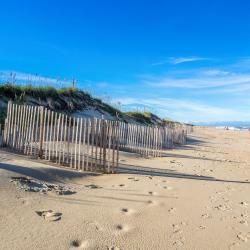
[3,102,119,173]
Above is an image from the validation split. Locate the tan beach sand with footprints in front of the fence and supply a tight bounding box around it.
[0,128,250,250]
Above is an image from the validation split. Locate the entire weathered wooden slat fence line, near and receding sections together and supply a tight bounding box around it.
[0,101,192,173]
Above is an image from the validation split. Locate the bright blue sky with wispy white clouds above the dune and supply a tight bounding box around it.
[0,0,250,121]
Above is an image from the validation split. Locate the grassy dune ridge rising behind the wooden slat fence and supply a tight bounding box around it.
[0,83,182,129]
